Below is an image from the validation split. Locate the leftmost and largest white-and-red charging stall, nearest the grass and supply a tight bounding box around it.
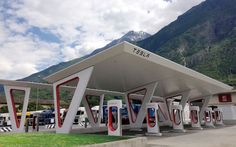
[107,100,122,136]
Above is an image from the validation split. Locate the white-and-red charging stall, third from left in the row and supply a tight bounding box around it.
[171,105,186,132]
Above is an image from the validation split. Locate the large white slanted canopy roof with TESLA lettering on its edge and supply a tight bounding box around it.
[45,42,232,98]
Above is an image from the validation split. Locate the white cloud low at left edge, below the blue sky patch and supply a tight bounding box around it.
[0,35,60,79]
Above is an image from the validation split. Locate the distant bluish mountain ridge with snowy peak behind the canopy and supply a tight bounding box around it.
[20,31,151,82]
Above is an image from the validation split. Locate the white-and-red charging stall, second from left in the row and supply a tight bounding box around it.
[146,103,162,136]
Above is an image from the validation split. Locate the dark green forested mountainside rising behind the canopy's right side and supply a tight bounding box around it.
[136,0,236,86]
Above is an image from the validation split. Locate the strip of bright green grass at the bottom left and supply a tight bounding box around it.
[0,133,128,147]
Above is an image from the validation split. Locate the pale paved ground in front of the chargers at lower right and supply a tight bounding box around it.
[148,126,236,147]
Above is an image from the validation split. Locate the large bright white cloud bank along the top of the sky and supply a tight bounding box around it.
[13,0,202,47]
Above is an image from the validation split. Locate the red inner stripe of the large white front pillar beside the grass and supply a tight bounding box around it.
[56,77,79,128]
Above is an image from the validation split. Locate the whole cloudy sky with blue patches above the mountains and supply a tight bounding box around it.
[0,0,203,79]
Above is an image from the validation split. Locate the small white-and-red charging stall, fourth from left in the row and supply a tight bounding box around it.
[189,106,202,129]
